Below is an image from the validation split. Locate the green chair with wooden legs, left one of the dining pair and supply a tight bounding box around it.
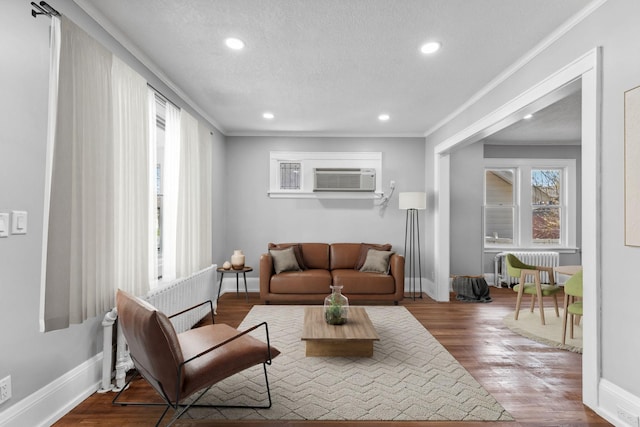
[507,254,561,325]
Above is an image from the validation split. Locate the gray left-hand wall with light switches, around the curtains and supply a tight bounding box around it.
[0,0,226,412]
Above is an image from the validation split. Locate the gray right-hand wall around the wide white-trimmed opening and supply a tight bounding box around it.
[426,0,640,399]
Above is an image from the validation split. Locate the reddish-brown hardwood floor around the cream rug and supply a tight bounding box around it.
[55,288,611,427]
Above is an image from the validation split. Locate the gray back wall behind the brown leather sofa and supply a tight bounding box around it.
[222,137,425,277]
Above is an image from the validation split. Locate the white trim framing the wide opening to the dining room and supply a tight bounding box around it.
[434,48,601,410]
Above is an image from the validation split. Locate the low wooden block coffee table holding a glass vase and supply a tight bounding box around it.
[302,307,380,357]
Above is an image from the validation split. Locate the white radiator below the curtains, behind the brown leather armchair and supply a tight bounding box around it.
[99,264,217,392]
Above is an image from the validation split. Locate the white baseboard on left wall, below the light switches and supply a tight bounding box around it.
[0,352,102,427]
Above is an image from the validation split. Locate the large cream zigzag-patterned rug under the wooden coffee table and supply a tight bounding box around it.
[183,305,513,421]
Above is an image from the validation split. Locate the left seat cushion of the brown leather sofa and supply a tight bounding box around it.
[269,269,331,295]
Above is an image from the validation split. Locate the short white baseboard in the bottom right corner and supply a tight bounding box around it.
[596,379,640,427]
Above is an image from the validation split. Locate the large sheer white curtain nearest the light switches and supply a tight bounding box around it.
[40,17,149,331]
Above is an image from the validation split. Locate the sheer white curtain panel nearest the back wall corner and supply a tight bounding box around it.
[176,110,211,277]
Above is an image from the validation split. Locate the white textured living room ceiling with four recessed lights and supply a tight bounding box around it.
[75,0,591,136]
